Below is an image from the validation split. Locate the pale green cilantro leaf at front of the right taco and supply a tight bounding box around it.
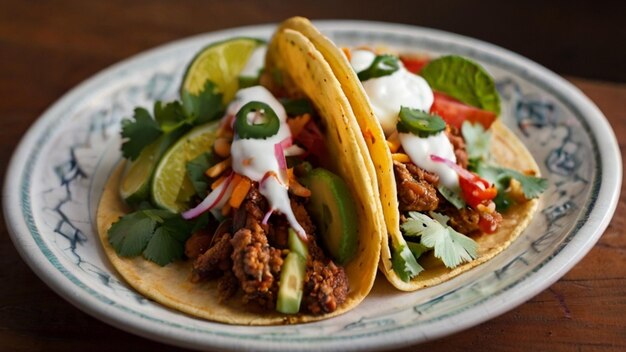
[400,211,478,269]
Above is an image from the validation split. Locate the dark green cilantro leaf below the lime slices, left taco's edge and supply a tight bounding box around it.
[108,209,194,266]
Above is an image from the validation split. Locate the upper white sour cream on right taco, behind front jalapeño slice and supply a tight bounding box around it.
[350,50,434,136]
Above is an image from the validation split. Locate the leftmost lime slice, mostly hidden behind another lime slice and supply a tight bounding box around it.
[120,132,182,205]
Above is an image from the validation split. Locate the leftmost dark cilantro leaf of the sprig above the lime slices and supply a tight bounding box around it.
[122,108,163,160]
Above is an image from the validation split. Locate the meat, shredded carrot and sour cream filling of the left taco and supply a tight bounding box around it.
[182,86,352,314]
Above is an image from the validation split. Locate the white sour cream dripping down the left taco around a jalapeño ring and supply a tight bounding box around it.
[224,86,304,234]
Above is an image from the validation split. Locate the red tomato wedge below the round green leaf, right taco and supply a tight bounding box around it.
[430,92,497,129]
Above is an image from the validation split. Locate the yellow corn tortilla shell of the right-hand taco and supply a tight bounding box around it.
[282,17,539,291]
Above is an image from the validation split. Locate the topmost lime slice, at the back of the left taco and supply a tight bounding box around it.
[180,38,265,104]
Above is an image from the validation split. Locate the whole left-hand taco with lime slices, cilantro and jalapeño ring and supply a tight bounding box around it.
[97,17,384,325]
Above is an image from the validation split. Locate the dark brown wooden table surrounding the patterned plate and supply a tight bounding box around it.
[0,1,626,351]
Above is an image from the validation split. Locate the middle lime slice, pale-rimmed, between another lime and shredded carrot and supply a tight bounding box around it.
[152,121,219,213]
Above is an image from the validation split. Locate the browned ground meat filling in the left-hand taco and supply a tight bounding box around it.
[185,184,349,314]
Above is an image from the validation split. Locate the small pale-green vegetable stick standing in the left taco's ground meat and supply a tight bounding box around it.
[276,251,306,314]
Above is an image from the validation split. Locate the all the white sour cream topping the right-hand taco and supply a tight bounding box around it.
[350,50,460,190]
